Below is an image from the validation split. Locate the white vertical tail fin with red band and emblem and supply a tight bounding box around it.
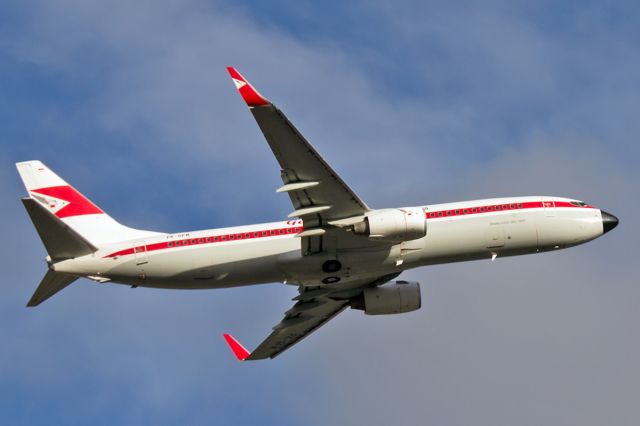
[16,161,157,246]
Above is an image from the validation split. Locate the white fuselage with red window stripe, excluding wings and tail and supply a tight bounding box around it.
[51,197,603,289]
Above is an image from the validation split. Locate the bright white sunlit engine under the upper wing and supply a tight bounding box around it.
[353,208,427,241]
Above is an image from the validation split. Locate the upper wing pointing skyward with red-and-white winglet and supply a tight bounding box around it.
[227,67,369,237]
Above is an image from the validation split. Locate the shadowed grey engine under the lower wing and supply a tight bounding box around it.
[351,281,421,315]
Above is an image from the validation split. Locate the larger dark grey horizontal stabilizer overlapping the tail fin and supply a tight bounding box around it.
[22,198,98,260]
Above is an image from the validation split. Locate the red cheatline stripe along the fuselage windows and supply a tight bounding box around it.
[104,201,593,258]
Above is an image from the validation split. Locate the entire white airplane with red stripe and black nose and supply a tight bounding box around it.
[16,67,618,361]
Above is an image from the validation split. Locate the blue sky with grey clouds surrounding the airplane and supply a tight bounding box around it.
[0,0,640,426]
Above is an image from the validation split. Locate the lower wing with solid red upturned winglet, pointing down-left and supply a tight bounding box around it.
[224,273,399,361]
